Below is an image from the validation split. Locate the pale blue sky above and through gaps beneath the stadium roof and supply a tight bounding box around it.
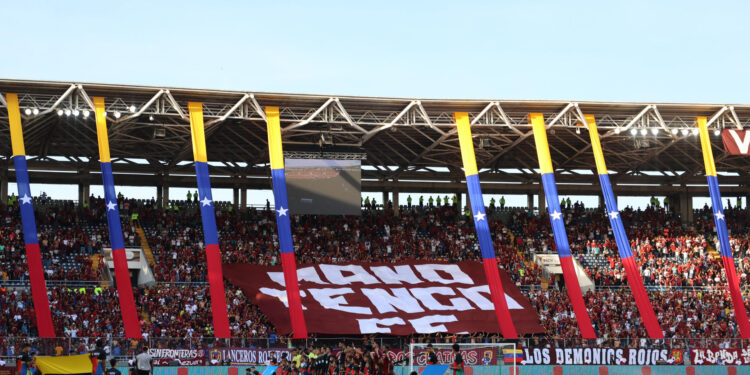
[0,0,750,209]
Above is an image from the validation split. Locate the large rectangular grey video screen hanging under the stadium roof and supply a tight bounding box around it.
[284,159,362,215]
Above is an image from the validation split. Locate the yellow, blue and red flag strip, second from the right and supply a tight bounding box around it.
[584,115,664,339]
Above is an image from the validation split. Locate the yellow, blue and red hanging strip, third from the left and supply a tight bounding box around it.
[188,102,231,338]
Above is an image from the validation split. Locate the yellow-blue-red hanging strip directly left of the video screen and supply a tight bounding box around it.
[266,107,307,339]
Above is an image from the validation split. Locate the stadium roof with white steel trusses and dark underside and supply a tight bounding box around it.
[0,79,750,195]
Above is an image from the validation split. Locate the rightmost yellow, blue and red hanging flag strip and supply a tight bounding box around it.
[695,117,750,339]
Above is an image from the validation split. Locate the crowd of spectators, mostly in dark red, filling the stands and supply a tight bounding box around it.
[0,197,750,356]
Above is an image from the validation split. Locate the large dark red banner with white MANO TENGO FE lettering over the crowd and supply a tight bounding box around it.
[224,261,544,335]
